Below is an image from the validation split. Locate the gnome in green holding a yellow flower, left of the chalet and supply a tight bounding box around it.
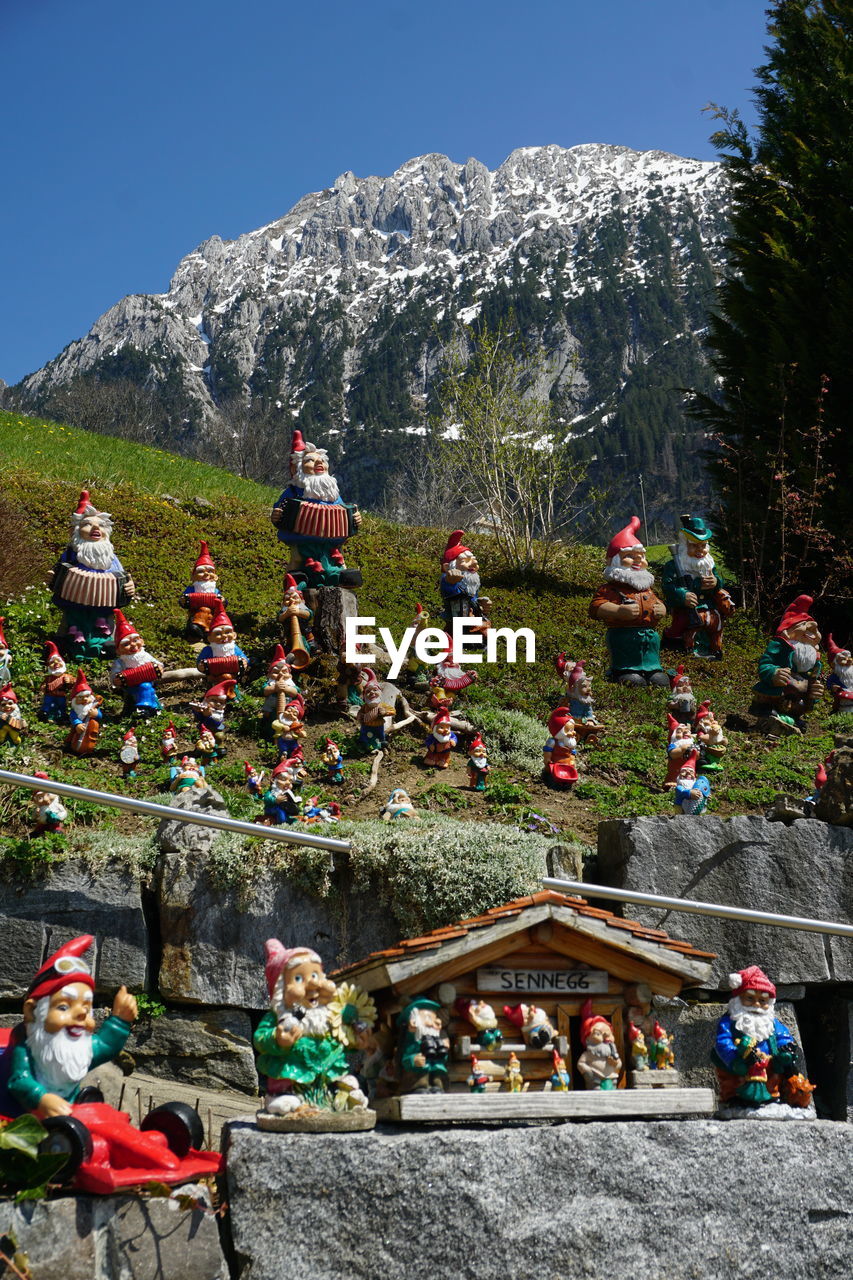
[252,938,366,1115]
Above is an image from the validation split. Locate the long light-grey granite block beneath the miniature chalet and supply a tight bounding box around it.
[225,1120,853,1280]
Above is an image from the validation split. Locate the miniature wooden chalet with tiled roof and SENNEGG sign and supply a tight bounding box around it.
[334,891,715,1123]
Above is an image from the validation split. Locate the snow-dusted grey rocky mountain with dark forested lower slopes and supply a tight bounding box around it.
[19,145,725,514]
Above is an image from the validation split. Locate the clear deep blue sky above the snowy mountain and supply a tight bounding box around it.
[0,0,766,383]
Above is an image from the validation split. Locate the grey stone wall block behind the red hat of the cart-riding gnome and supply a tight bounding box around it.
[0,859,149,1000]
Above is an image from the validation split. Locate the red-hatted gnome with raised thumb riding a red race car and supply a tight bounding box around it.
[0,933,222,1193]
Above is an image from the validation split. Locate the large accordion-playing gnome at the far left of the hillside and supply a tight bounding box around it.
[49,489,136,658]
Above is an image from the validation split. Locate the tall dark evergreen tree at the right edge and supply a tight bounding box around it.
[695,0,853,616]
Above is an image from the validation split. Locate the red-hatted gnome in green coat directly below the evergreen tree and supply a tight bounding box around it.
[749,595,824,733]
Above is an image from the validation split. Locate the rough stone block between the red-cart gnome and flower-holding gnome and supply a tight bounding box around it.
[127,1009,257,1094]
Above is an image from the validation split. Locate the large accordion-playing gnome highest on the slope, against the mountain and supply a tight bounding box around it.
[270,430,361,586]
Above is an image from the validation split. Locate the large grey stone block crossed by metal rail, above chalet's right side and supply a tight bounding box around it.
[589,817,853,991]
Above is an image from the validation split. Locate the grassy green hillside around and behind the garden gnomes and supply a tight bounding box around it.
[0,413,833,906]
